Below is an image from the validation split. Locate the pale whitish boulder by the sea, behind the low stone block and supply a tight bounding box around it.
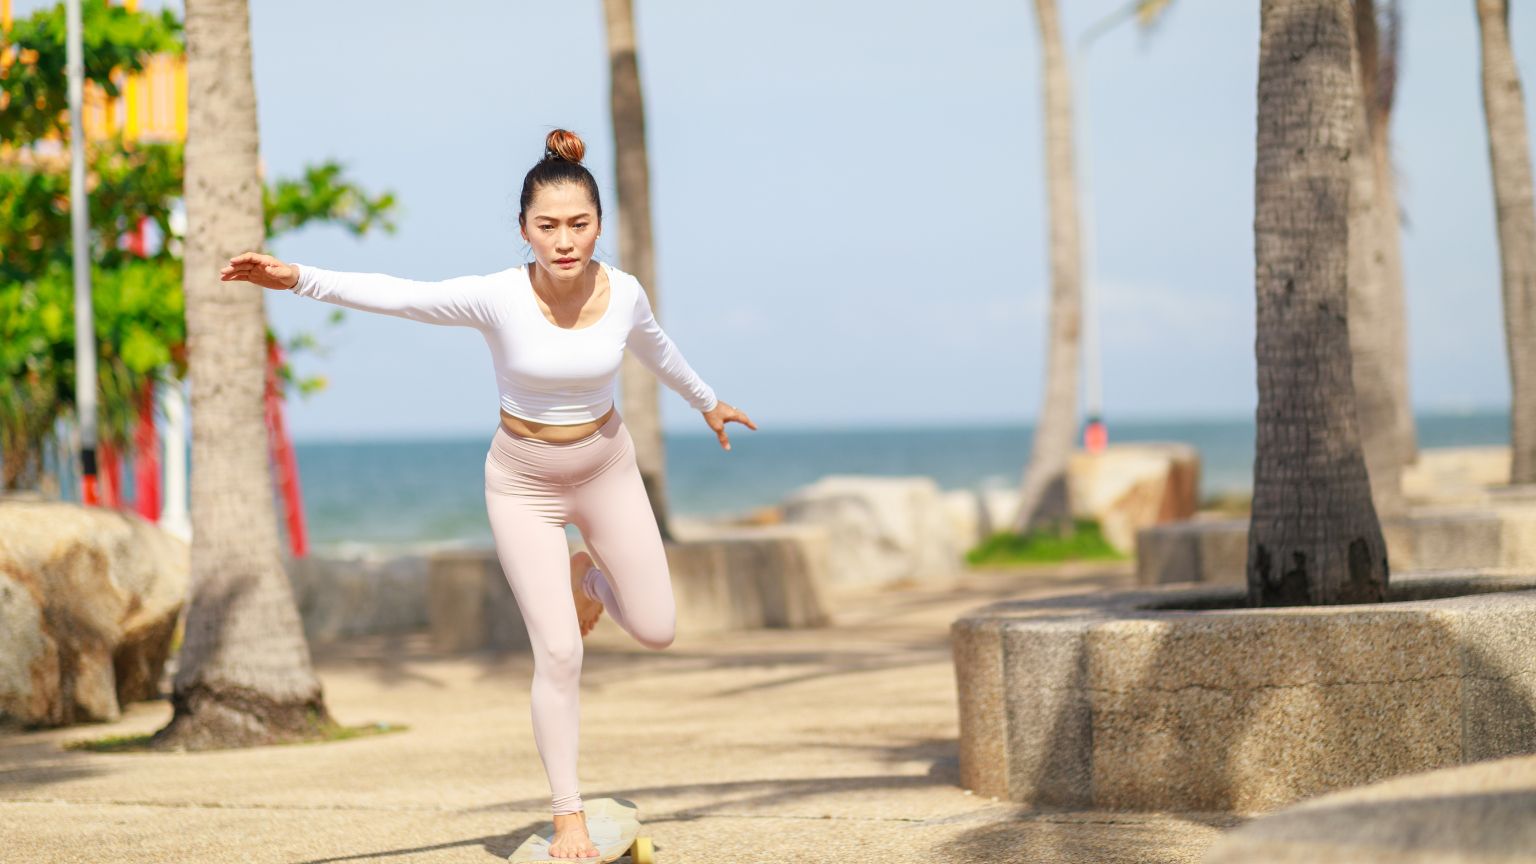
[782,474,965,583]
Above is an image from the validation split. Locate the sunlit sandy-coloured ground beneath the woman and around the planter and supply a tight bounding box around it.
[0,564,1236,864]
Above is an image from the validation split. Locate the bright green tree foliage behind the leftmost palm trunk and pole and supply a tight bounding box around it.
[0,0,395,489]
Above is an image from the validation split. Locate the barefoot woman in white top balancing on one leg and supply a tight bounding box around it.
[221,129,757,858]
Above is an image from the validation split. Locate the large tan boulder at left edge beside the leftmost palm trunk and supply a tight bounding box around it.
[0,501,190,726]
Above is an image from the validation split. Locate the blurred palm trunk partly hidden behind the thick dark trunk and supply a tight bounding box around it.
[1349,0,1404,517]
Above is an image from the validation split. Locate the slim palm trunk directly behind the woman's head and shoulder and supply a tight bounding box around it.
[602,0,671,540]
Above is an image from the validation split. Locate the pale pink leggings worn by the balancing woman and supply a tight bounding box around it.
[485,410,676,813]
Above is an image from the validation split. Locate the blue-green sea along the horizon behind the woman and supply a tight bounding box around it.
[282,410,1508,552]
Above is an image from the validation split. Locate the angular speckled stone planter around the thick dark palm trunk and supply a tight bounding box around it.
[951,572,1536,812]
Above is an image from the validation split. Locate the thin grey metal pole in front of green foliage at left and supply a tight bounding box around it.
[65,0,97,504]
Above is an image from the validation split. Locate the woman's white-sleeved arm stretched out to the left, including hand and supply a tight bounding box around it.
[220,252,501,327]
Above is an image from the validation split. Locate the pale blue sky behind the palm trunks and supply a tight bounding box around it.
[15,0,1536,440]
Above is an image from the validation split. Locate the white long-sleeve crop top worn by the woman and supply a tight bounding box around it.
[290,263,716,426]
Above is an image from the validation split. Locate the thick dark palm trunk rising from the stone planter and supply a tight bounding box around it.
[1247,0,1387,606]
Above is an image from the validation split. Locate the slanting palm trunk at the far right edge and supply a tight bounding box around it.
[1476,0,1536,483]
